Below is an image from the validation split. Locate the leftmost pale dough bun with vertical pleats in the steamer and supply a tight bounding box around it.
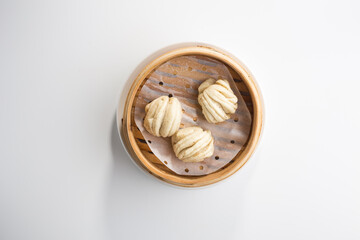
[144,96,182,137]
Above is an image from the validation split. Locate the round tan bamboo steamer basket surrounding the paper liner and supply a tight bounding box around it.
[117,45,263,187]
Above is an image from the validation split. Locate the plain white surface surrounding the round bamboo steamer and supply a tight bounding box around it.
[0,0,360,240]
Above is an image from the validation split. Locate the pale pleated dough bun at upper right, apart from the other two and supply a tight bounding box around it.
[198,78,238,123]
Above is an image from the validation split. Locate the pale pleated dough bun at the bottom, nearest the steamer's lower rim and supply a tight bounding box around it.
[171,127,214,162]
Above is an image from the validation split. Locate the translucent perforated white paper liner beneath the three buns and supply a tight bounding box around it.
[134,56,252,175]
